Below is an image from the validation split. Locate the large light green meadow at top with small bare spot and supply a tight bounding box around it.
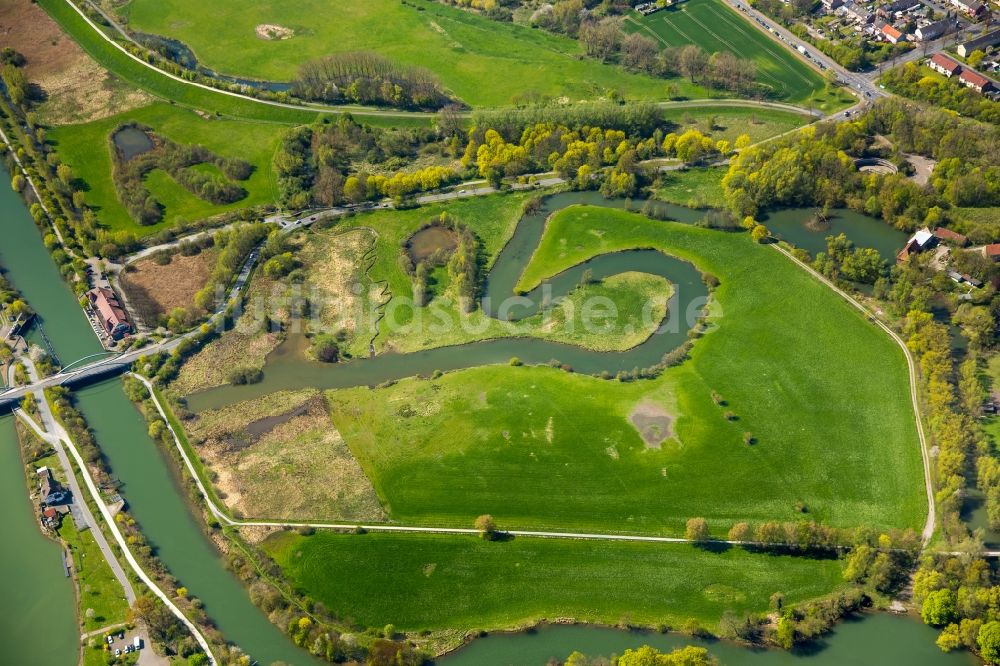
[124,0,704,106]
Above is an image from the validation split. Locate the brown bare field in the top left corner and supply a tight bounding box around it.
[0,0,152,125]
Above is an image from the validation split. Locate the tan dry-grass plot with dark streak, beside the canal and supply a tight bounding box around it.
[191,390,385,520]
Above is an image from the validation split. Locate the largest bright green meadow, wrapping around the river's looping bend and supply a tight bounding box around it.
[328,208,925,534]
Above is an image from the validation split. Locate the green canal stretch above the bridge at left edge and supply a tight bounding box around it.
[0,166,102,365]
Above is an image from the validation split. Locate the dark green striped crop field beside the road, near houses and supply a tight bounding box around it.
[626,0,834,109]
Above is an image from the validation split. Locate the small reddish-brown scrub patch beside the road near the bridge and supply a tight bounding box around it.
[118,249,218,326]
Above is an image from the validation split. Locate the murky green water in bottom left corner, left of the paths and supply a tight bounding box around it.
[0,416,79,666]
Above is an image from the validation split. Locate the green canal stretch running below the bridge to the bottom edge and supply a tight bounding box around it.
[76,380,316,666]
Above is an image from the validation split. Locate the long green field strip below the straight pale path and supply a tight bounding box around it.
[263,531,842,631]
